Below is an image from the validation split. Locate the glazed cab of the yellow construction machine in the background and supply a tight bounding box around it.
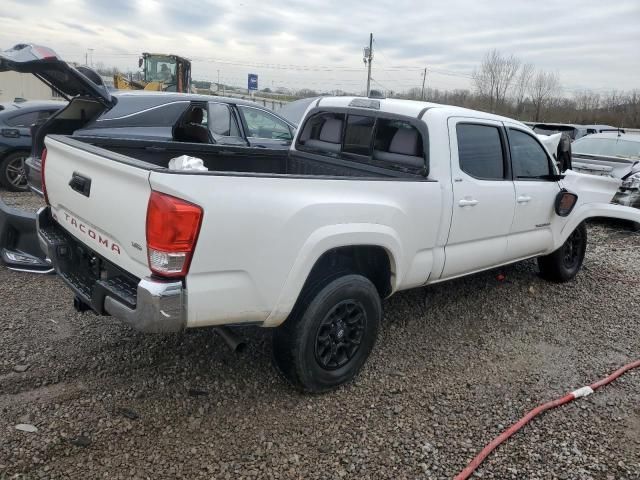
[138,53,191,93]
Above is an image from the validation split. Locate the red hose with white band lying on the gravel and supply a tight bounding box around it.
[455,360,640,480]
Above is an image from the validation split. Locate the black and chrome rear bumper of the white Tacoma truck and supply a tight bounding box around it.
[37,207,186,333]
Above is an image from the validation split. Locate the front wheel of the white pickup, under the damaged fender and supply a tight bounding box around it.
[538,222,587,283]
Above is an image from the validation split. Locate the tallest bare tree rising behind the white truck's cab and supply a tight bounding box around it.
[472,49,520,112]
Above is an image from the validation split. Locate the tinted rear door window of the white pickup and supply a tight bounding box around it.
[456,123,505,180]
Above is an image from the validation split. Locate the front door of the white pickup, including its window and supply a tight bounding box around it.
[506,124,560,260]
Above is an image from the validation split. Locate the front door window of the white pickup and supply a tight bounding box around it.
[509,128,551,180]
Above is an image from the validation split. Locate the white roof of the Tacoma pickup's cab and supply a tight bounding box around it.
[310,97,526,126]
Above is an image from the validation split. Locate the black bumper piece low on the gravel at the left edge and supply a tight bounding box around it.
[0,199,54,273]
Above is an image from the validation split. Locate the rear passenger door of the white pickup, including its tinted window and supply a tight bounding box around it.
[442,118,515,278]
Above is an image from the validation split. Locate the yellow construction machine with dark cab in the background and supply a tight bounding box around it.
[113,52,191,93]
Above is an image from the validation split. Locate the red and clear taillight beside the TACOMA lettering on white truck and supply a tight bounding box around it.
[147,192,202,277]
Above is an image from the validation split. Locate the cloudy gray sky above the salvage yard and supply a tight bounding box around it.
[0,0,640,95]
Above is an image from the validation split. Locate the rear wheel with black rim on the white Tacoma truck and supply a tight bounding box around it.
[273,273,382,393]
